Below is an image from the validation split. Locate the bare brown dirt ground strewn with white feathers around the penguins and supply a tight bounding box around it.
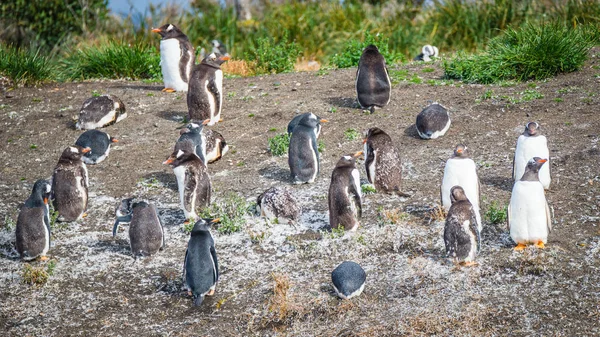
[0,48,600,336]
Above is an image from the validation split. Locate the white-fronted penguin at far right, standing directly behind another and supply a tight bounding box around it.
[513,122,550,190]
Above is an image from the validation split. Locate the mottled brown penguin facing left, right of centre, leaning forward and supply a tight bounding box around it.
[363,128,402,193]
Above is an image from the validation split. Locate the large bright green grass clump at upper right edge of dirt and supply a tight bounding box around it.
[444,23,594,84]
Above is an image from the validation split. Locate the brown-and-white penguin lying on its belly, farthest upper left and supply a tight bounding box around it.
[75,95,127,130]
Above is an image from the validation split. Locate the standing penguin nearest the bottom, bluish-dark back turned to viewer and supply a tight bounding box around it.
[183,219,219,306]
